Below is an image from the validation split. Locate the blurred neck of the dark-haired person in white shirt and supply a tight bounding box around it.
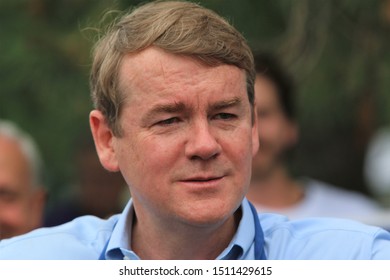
[247,166,304,209]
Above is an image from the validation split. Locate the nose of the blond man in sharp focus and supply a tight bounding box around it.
[185,121,221,160]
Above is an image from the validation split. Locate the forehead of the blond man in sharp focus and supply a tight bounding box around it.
[119,47,246,104]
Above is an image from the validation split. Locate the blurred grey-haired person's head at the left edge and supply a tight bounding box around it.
[0,120,46,239]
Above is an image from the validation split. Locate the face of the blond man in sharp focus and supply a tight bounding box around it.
[101,48,258,226]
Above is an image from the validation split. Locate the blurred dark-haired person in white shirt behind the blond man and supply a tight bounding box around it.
[248,53,379,221]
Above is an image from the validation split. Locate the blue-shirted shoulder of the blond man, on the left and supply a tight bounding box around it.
[0,215,118,259]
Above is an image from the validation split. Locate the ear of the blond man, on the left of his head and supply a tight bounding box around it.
[89,110,119,171]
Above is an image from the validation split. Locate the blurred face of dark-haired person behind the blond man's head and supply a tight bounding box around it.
[252,76,297,180]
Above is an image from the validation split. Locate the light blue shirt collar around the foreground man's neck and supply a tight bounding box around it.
[105,199,255,260]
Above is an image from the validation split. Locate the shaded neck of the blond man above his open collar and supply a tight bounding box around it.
[131,206,241,260]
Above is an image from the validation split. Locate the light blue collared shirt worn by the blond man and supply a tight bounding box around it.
[0,199,390,260]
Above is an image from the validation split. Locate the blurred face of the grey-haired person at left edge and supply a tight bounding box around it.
[0,136,43,239]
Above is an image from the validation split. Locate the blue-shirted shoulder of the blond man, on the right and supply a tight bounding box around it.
[259,214,390,260]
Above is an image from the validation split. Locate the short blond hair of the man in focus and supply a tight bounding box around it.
[90,1,255,136]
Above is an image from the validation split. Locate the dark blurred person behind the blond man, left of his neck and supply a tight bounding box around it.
[44,137,129,226]
